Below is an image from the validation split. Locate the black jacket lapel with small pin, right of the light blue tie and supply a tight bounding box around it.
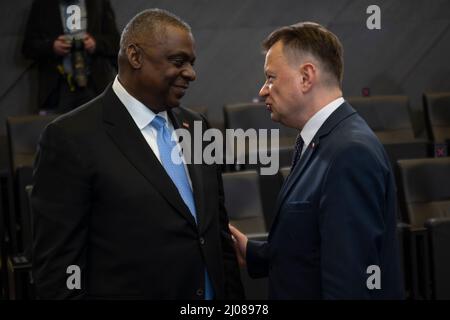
[167,108,206,230]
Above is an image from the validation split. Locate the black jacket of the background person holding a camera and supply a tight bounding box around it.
[22,0,120,108]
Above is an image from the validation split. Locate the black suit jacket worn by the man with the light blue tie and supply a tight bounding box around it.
[32,88,243,299]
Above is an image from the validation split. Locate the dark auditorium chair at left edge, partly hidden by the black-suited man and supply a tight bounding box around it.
[6,115,57,299]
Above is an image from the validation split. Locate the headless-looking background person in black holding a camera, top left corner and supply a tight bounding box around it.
[23,0,119,113]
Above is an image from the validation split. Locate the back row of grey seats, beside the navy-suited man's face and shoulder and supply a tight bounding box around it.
[224,92,450,145]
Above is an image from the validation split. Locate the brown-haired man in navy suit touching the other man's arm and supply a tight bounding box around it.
[230,23,403,299]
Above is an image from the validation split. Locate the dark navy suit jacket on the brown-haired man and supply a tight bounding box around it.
[247,102,403,299]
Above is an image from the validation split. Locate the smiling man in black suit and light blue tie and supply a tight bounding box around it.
[32,9,243,300]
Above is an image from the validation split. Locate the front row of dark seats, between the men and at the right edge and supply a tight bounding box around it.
[223,157,450,299]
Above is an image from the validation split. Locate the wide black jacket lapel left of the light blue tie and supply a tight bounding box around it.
[103,87,196,226]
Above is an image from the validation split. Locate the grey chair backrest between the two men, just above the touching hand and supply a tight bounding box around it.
[222,170,267,234]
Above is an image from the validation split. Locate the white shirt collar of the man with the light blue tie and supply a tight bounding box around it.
[112,76,168,130]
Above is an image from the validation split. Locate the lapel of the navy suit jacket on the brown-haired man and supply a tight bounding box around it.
[272,102,356,235]
